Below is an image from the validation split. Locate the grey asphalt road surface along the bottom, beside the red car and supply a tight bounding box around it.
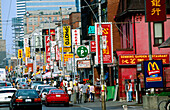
[0,100,143,110]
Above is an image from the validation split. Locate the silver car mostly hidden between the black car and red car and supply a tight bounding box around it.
[39,87,56,102]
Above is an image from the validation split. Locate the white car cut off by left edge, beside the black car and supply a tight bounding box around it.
[0,88,17,104]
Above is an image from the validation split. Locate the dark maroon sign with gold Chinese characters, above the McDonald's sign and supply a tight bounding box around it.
[145,0,166,22]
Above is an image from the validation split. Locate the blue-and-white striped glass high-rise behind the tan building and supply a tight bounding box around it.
[16,0,80,37]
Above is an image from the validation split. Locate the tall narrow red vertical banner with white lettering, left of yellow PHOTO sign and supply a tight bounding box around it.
[45,36,51,63]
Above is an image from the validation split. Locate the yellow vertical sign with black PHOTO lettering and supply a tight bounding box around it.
[63,26,71,47]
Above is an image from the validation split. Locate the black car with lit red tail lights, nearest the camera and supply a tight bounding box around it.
[9,89,42,110]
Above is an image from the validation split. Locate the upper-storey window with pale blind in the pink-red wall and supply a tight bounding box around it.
[154,22,164,46]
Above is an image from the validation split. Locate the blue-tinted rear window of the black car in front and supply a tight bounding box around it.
[17,90,38,96]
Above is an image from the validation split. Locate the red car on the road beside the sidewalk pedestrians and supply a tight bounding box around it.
[45,89,69,106]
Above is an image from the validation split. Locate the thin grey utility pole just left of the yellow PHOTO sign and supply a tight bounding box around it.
[60,7,65,79]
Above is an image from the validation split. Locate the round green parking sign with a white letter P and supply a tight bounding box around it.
[77,46,88,58]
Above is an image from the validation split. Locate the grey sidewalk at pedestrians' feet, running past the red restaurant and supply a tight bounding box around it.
[71,98,142,107]
